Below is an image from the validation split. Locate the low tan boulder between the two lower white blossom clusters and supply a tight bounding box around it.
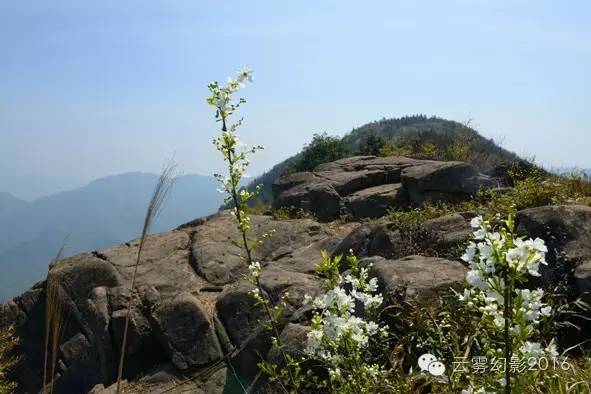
[370,256,467,305]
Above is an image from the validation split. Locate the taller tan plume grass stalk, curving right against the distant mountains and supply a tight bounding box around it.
[117,161,176,394]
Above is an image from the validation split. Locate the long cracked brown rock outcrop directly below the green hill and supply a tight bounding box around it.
[273,156,495,220]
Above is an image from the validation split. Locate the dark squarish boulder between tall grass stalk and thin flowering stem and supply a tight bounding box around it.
[153,293,222,370]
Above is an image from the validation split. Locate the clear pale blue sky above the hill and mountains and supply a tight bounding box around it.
[0,0,591,199]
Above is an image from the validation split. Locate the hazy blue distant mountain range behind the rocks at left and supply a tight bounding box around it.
[0,172,222,301]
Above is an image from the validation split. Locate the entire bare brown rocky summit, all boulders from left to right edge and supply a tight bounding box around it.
[0,156,591,393]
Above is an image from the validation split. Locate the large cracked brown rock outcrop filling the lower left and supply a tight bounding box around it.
[0,212,352,393]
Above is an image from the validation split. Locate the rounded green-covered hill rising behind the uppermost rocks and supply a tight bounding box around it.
[248,115,520,204]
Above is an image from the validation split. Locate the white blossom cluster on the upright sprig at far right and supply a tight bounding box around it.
[458,216,557,390]
